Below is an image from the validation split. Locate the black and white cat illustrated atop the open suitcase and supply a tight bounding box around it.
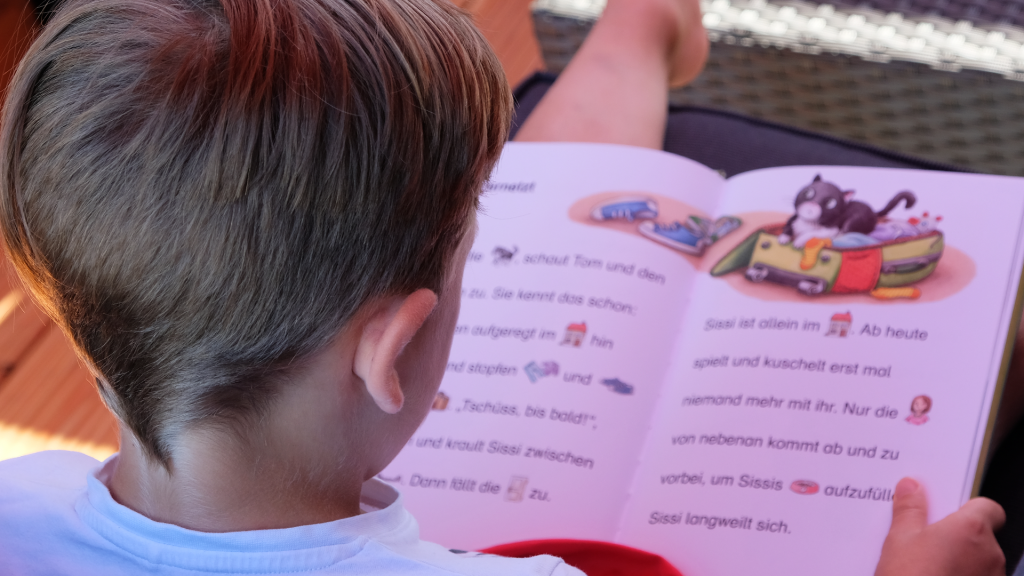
[778,174,918,248]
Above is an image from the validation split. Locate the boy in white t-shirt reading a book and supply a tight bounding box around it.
[0,0,1001,575]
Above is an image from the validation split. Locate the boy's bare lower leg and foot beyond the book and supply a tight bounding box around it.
[516,0,708,150]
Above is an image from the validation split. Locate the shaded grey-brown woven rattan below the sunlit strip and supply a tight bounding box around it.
[535,9,1024,176]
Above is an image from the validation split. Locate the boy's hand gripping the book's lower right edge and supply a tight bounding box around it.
[874,478,1007,576]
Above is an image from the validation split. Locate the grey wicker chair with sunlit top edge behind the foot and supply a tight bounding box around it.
[534,0,1024,175]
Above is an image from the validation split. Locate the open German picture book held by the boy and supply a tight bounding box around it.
[380,143,1024,575]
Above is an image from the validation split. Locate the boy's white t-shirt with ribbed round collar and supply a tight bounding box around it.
[0,451,583,576]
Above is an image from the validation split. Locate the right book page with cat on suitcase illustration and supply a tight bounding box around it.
[620,167,1024,576]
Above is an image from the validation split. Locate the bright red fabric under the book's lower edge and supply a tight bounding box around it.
[480,540,683,576]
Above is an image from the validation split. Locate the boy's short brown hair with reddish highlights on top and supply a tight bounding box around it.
[0,0,511,465]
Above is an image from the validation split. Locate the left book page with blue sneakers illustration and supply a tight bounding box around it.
[380,143,724,549]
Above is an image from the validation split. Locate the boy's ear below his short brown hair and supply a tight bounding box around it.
[352,288,437,414]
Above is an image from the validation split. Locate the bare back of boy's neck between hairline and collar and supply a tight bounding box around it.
[108,332,387,532]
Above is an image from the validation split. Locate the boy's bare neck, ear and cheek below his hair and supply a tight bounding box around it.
[98,258,460,532]
